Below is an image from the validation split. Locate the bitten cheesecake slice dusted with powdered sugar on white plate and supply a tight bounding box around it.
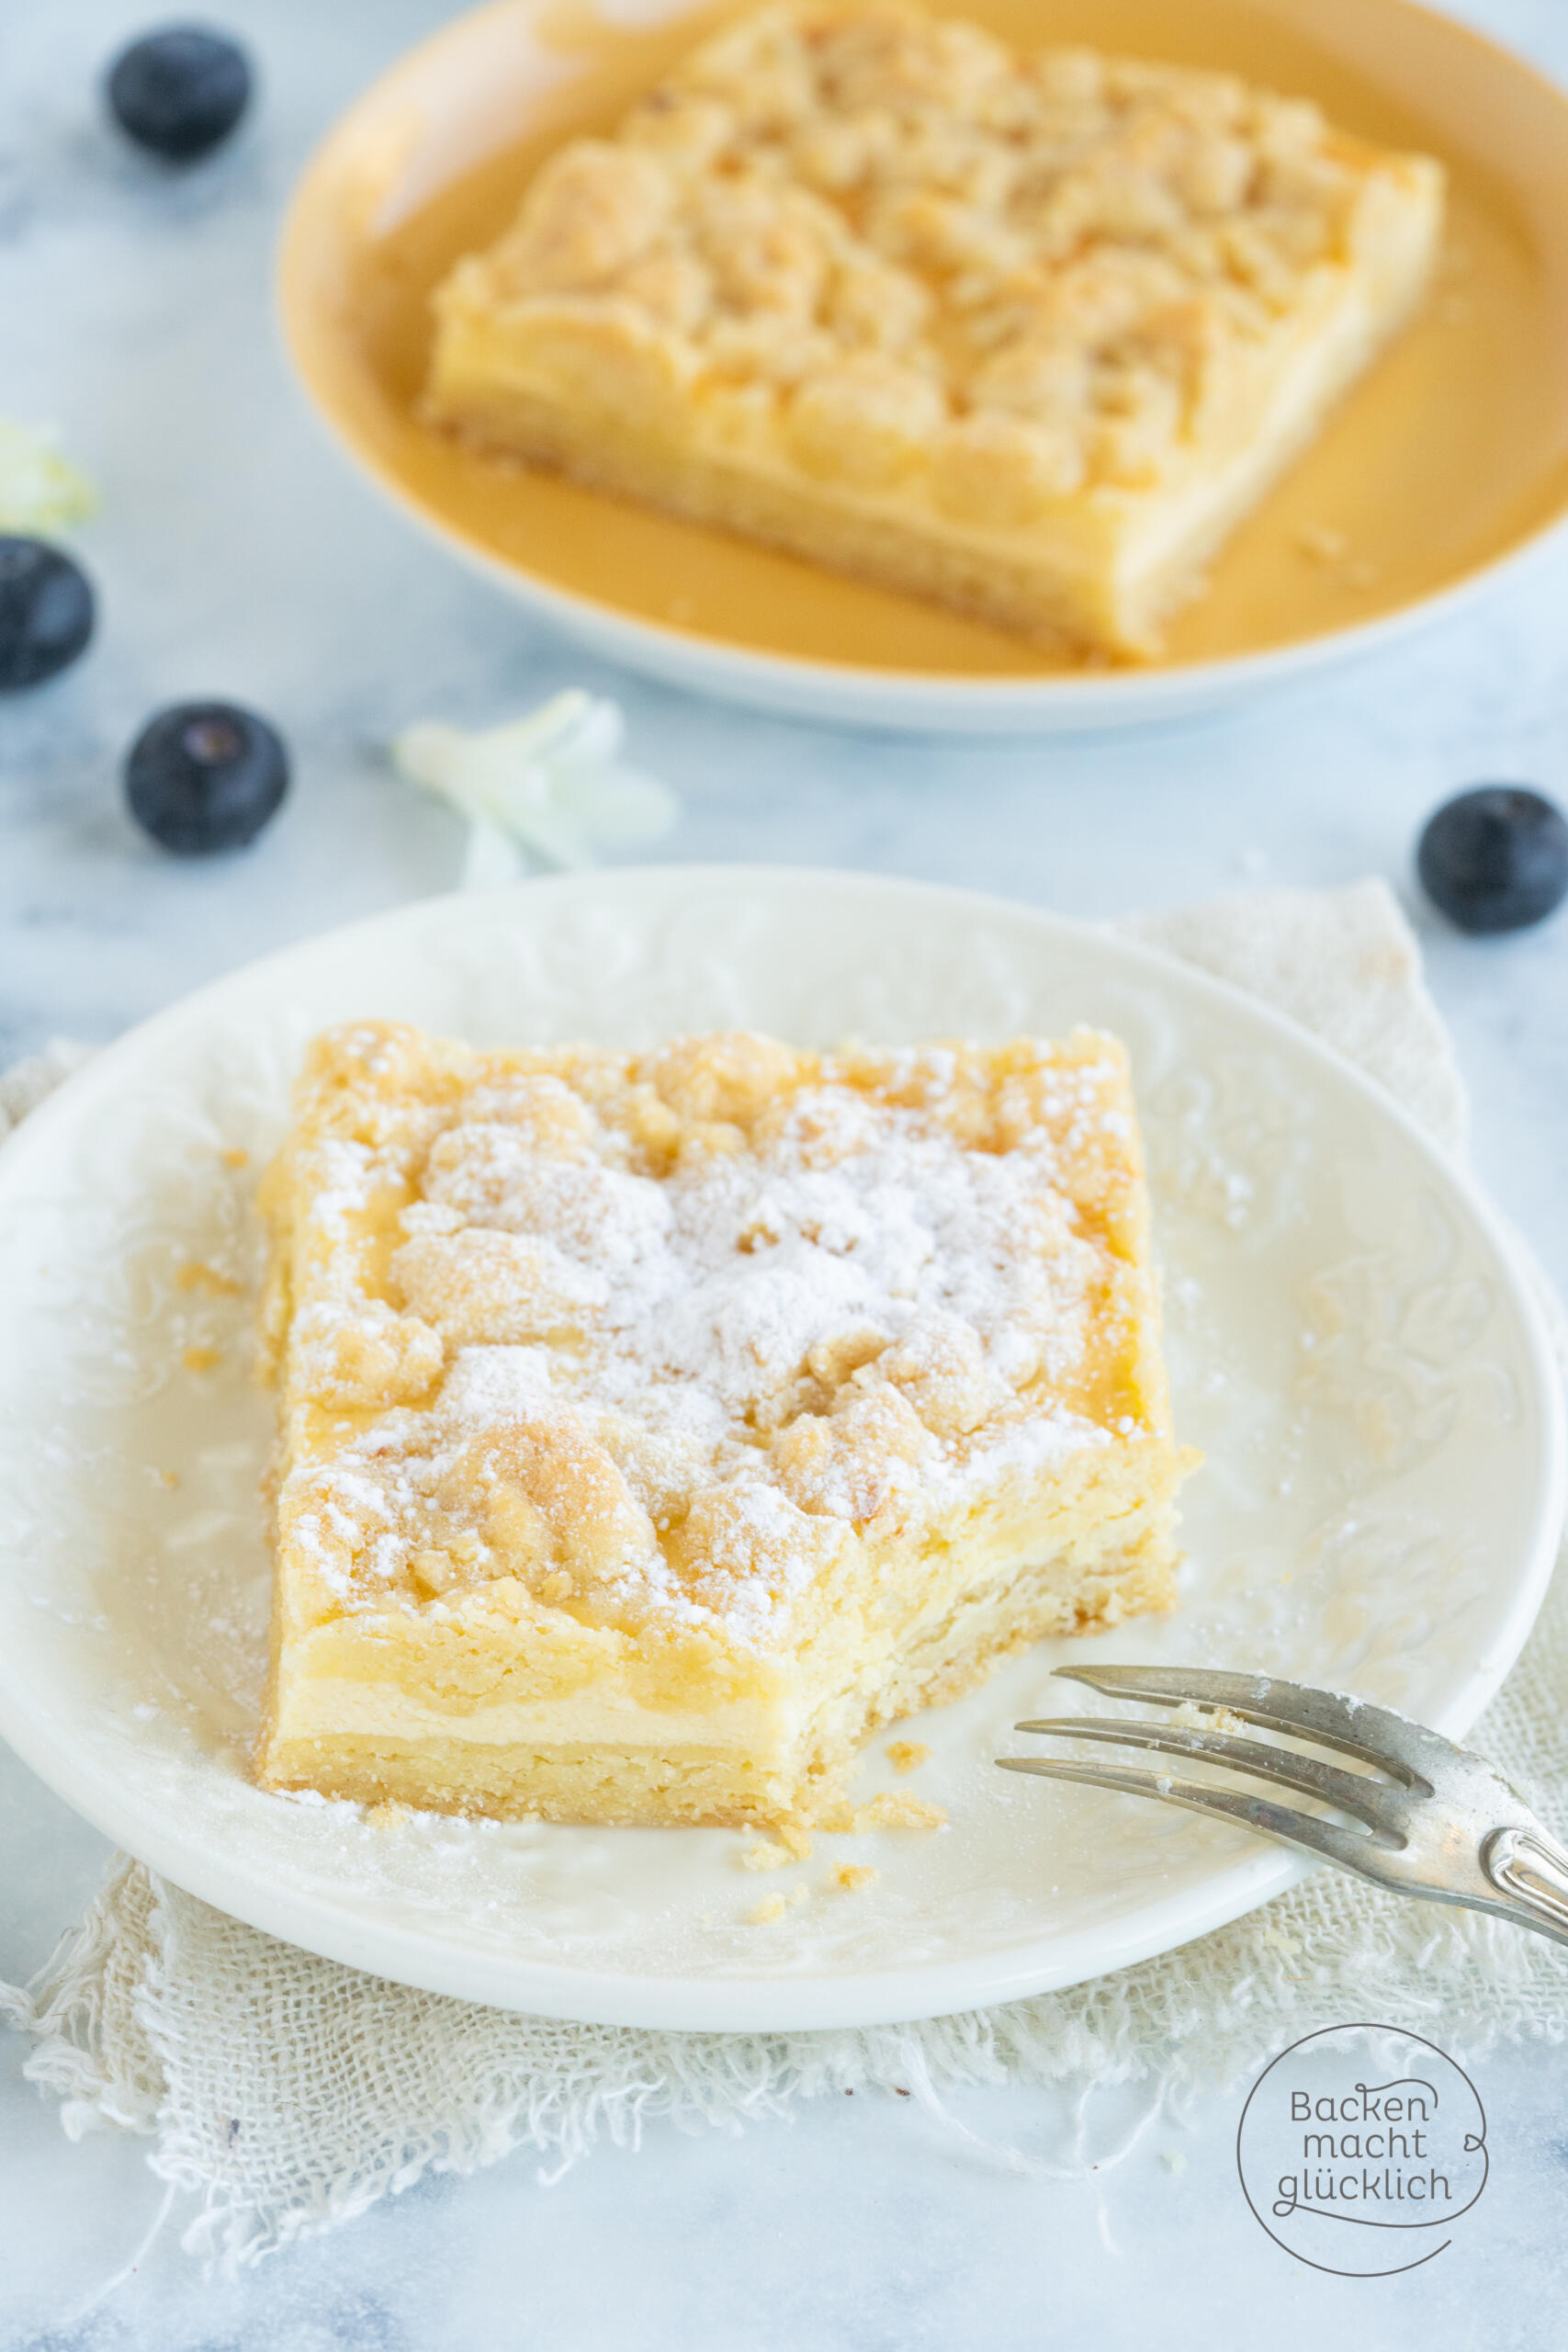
[259,1023,1192,1823]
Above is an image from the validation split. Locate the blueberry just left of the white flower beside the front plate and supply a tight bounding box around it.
[125,703,289,858]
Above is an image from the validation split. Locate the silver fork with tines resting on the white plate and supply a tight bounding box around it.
[997,1665,1568,1943]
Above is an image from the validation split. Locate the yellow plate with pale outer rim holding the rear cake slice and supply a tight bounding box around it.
[280,0,1568,727]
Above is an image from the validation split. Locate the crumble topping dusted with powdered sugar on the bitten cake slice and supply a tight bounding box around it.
[273,1025,1138,1646]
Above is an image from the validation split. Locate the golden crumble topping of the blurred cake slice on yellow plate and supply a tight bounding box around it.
[437,0,1434,505]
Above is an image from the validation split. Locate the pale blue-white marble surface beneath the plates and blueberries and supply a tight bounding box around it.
[0,0,1568,2352]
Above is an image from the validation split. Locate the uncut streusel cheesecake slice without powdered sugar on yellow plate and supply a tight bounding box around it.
[425,0,1443,659]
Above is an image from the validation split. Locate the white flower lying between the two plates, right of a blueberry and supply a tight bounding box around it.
[392,687,680,889]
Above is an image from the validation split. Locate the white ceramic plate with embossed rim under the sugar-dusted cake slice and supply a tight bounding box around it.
[0,868,1563,2030]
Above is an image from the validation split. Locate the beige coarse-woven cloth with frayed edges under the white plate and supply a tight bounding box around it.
[0,882,1568,2267]
